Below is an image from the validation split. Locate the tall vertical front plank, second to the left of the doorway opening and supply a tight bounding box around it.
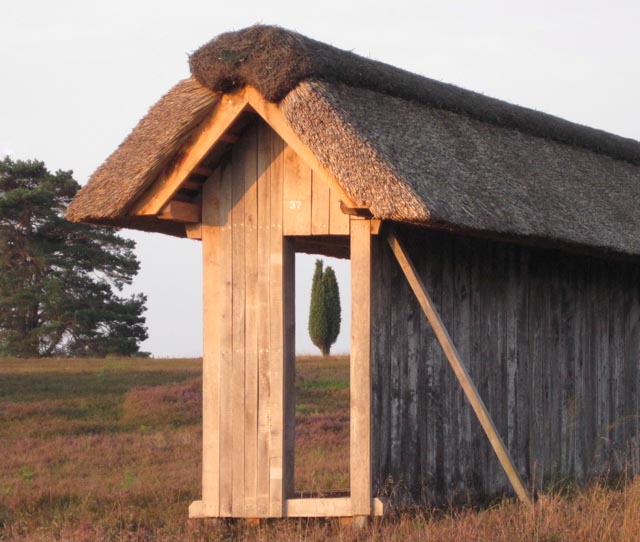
[256,122,271,517]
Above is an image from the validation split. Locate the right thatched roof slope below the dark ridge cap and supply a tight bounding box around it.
[281,81,640,254]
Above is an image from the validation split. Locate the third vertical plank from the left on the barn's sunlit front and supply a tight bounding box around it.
[231,138,247,517]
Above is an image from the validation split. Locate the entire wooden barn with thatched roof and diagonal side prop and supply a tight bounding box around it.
[67,26,640,518]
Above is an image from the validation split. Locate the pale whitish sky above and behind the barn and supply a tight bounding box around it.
[0,0,640,356]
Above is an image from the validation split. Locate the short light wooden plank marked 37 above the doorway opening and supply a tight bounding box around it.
[282,145,311,235]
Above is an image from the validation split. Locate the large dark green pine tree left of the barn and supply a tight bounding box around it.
[0,158,147,357]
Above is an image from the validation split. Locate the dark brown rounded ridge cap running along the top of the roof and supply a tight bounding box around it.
[189,25,640,165]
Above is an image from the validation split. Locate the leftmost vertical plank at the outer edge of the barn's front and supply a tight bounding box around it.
[202,169,222,517]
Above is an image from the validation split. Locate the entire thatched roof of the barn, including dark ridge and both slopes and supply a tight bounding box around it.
[69,26,640,254]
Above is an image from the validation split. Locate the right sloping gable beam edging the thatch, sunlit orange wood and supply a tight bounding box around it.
[244,86,356,207]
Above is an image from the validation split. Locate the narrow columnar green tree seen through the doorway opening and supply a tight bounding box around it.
[309,260,341,356]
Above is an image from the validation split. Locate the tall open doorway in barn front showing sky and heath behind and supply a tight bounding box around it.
[293,236,351,498]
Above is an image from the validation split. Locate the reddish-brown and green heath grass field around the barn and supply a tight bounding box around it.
[0,358,640,542]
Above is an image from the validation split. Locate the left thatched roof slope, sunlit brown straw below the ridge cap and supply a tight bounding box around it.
[66,78,219,235]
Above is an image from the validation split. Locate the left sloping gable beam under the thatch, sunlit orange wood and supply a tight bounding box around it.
[131,94,248,215]
